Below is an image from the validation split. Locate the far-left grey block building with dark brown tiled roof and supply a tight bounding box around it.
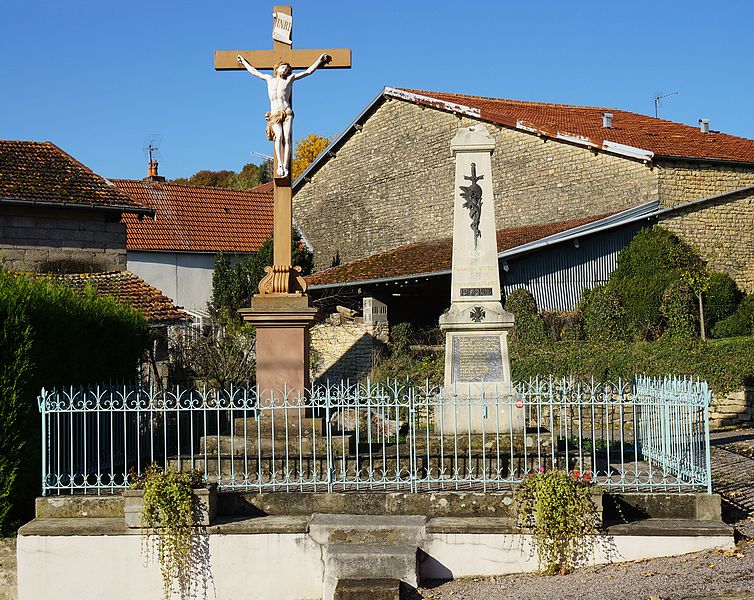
[0,140,155,273]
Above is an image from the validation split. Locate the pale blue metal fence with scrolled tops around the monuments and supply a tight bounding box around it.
[38,377,711,495]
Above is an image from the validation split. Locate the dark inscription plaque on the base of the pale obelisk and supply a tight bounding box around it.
[452,335,504,383]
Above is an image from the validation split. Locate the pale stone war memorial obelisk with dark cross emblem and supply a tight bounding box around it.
[434,124,524,434]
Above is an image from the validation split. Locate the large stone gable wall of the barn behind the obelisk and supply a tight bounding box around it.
[293,100,658,270]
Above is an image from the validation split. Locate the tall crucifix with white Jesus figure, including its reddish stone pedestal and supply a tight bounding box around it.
[215,6,351,401]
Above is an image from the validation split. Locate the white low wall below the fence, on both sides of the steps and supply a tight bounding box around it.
[17,519,734,600]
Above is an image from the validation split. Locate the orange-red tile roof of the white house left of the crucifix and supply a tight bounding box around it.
[113,179,272,252]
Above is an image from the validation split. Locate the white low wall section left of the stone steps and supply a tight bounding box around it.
[17,519,323,600]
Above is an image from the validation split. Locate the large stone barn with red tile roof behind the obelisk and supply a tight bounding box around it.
[294,88,754,291]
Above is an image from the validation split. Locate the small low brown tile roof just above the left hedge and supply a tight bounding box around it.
[42,271,190,325]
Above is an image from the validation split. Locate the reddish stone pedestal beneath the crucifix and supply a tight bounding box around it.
[239,294,318,405]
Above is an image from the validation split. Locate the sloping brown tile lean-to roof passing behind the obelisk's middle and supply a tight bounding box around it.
[306,215,608,286]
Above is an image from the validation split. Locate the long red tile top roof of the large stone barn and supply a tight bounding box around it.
[388,88,754,163]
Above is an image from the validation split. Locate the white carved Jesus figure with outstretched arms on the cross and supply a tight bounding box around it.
[237,53,332,177]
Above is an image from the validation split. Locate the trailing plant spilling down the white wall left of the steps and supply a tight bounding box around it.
[131,465,206,600]
